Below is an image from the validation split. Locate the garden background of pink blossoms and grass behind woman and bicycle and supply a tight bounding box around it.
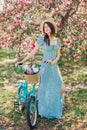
[0,0,87,130]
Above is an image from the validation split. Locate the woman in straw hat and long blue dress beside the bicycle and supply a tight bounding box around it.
[17,20,65,119]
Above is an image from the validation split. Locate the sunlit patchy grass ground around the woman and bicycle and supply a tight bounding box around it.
[0,50,87,130]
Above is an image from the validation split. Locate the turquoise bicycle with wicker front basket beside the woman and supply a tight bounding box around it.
[14,65,38,129]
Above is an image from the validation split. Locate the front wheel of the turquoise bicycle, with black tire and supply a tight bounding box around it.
[27,97,38,129]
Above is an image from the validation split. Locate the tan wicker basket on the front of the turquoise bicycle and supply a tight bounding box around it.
[24,73,39,84]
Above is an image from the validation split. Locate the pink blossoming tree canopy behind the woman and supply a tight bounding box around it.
[0,0,87,61]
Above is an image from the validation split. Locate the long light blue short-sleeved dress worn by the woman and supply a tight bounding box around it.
[37,36,64,119]
